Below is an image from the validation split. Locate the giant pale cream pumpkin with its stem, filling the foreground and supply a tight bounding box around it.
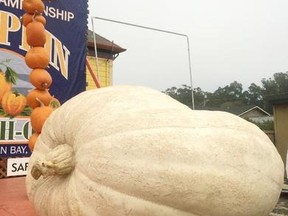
[26,86,284,216]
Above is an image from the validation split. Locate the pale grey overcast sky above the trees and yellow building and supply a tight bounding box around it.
[89,0,288,92]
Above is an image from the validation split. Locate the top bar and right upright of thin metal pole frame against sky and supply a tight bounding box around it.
[92,16,195,110]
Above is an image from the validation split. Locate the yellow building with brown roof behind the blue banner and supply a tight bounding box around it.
[86,30,126,90]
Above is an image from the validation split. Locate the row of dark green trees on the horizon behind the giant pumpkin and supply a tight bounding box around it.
[164,72,288,113]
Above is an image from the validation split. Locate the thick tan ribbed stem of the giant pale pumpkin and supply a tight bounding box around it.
[31,144,75,180]
